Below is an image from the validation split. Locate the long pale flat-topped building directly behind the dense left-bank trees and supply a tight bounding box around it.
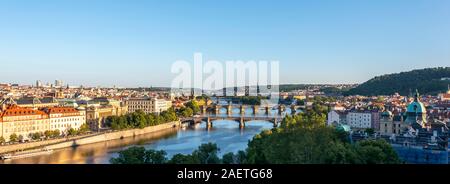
[126,97,172,113]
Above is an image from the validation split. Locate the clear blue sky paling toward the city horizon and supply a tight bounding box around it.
[0,0,450,87]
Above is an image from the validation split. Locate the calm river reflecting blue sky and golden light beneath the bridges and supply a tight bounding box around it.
[0,106,289,164]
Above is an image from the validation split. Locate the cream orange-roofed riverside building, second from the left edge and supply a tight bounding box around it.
[44,107,86,134]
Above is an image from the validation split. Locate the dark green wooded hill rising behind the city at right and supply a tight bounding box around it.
[343,67,450,96]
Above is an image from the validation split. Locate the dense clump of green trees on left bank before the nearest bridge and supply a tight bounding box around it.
[106,108,178,130]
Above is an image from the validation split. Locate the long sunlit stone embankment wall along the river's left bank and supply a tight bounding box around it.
[0,121,180,154]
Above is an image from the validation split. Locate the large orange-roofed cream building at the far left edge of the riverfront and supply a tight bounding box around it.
[0,105,50,142]
